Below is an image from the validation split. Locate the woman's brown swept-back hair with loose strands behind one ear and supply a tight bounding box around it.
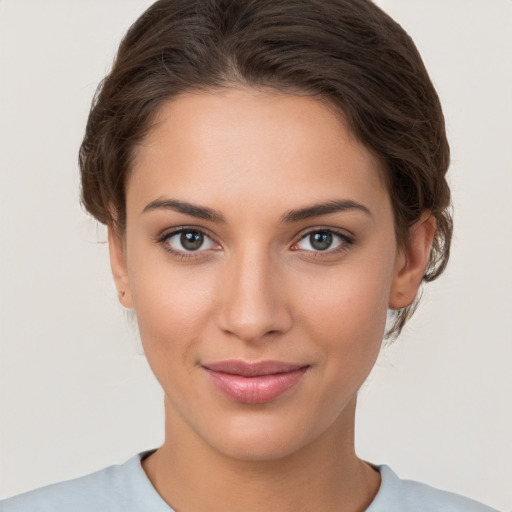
[79,0,452,336]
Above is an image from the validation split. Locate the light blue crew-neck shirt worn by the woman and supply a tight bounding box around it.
[0,452,497,512]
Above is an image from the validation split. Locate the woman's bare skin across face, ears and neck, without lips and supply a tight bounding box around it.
[109,88,435,512]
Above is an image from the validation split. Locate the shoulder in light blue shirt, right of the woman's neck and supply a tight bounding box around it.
[367,466,497,512]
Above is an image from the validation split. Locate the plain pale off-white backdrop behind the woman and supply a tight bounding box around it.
[0,0,512,510]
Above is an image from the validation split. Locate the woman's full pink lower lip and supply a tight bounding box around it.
[205,367,307,404]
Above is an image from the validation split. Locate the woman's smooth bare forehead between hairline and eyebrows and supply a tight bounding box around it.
[127,85,387,216]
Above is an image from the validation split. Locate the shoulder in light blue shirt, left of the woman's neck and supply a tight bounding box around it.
[0,454,172,512]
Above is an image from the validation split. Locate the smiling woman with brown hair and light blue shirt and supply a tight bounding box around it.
[0,0,500,512]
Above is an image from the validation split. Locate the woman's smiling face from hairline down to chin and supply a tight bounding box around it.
[110,89,428,460]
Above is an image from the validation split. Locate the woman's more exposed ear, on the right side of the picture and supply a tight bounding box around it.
[388,212,436,309]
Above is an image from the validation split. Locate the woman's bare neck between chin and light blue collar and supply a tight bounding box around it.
[143,400,380,512]
